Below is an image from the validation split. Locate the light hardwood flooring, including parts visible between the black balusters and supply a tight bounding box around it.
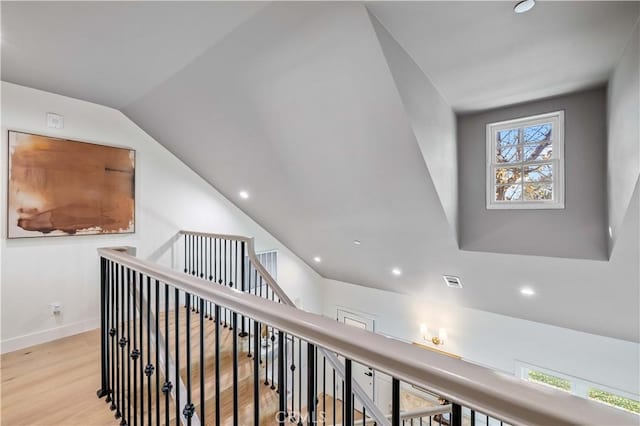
[0,310,440,426]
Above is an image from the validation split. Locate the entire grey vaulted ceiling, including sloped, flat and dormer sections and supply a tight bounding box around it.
[2,2,640,341]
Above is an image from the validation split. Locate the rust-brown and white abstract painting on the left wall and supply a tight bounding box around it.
[7,131,135,238]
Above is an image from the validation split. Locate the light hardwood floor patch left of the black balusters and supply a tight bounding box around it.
[0,330,118,426]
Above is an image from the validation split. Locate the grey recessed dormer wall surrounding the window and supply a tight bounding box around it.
[458,87,608,261]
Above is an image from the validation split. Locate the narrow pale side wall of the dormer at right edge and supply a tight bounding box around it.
[607,21,640,252]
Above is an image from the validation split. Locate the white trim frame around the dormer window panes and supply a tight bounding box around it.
[485,111,565,210]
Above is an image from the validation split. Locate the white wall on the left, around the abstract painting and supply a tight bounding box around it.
[0,82,321,353]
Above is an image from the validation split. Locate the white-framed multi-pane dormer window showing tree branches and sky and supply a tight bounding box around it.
[487,111,564,209]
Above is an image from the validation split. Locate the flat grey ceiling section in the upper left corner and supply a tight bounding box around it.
[1,1,267,109]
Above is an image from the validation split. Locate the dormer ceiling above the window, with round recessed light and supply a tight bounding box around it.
[367,1,640,112]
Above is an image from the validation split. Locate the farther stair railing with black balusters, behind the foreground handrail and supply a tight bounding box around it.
[178,230,389,426]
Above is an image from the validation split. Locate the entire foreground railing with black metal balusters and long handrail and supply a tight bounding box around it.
[99,249,637,426]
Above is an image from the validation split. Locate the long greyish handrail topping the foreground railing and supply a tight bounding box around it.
[98,248,638,426]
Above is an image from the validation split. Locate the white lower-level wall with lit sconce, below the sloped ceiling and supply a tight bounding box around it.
[323,280,640,395]
